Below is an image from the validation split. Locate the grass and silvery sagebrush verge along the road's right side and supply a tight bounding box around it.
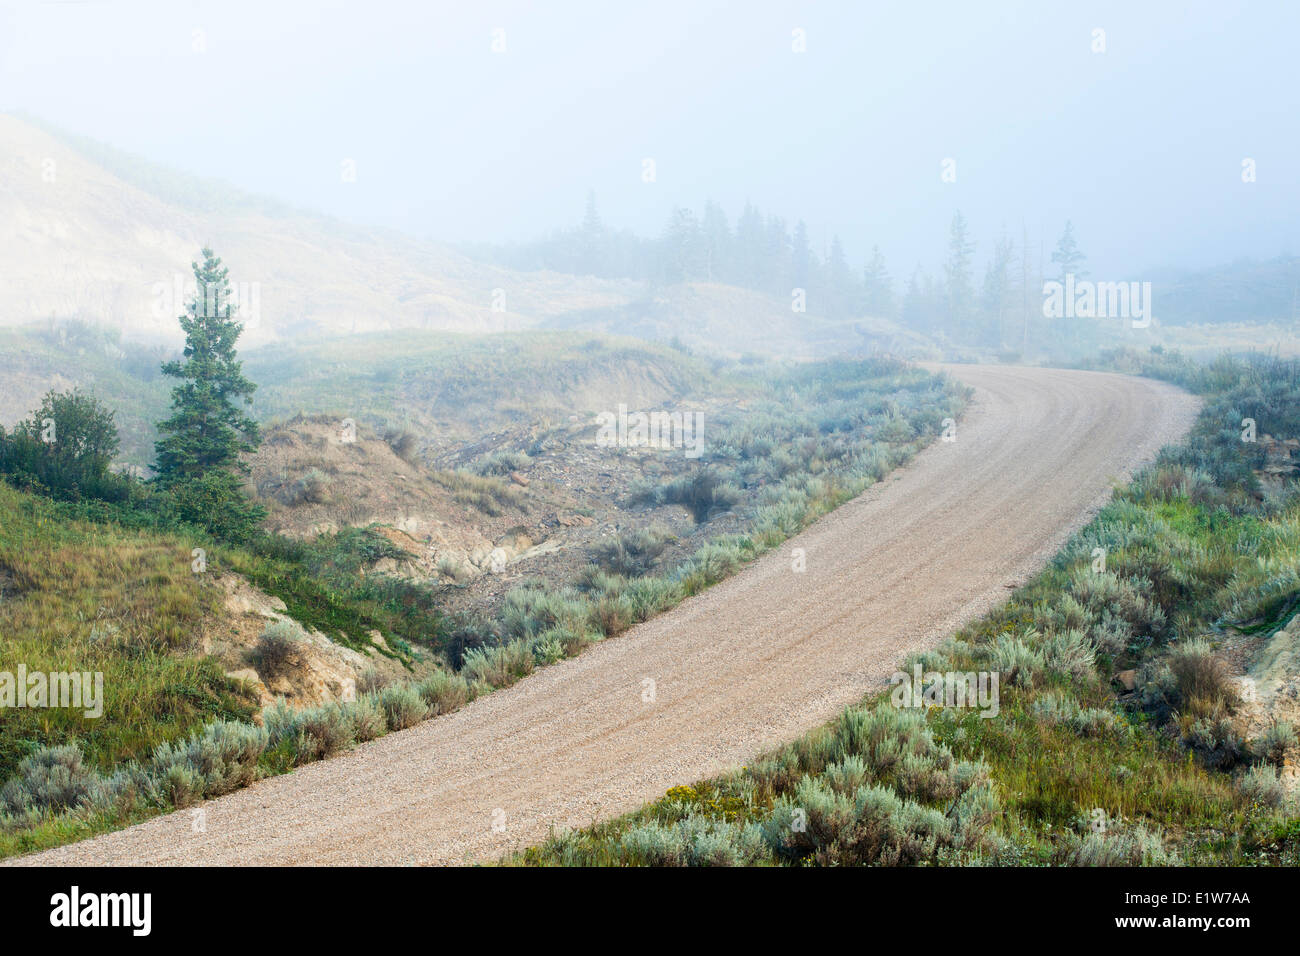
[507,354,1300,865]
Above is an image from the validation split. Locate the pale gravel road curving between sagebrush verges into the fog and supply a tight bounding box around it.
[16,365,1197,865]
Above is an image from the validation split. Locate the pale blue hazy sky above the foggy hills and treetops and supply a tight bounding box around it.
[0,0,1300,280]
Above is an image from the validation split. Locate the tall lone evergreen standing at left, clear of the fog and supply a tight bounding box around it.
[153,248,264,537]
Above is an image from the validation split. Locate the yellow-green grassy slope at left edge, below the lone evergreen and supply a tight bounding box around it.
[0,483,252,779]
